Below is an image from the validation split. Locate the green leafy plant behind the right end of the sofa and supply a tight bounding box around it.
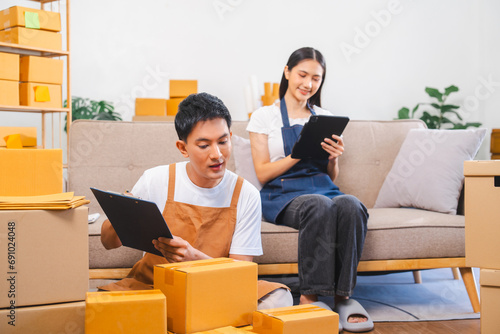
[397,85,481,129]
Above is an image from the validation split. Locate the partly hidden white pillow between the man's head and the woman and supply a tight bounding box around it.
[231,135,262,190]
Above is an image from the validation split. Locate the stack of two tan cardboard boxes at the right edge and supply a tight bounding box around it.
[464,160,500,334]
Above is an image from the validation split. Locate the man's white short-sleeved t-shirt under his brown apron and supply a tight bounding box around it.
[132,161,262,256]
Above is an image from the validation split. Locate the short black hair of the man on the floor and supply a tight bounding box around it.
[175,93,231,142]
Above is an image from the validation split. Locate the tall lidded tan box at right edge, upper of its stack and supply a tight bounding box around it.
[464,160,500,269]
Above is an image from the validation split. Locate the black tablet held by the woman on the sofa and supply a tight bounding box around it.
[292,115,349,159]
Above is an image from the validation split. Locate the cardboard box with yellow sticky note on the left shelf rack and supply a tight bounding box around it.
[19,82,62,108]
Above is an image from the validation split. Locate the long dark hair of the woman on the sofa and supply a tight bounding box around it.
[280,47,326,107]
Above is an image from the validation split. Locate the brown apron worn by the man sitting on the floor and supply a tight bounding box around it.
[99,164,288,299]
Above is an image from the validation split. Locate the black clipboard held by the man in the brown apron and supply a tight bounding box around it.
[90,188,173,256]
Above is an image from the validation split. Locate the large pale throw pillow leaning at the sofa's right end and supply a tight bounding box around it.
[374,129,486,214]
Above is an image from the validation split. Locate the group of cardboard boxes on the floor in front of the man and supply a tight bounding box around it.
[86,258,338,334]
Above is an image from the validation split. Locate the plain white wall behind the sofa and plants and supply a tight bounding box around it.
[0,0,500,159]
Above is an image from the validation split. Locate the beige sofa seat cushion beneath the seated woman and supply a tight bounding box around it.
[255,208,465,264]
